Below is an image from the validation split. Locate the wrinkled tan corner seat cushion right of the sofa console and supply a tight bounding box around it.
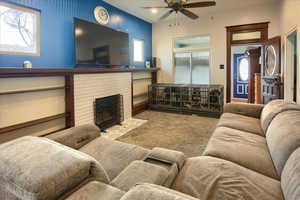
[172,156,283,200]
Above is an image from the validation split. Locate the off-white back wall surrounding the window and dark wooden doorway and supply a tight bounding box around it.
[153,3,280,99]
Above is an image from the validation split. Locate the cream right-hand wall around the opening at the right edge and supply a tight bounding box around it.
[280,0,300,103]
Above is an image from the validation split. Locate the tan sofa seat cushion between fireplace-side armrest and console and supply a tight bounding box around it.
[79,137,149,180]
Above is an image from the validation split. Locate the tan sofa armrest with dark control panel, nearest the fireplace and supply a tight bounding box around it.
[47,124,101,150]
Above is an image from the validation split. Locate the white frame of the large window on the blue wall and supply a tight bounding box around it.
[0,2,41,56]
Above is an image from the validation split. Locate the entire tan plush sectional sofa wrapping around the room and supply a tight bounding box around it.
[0,100,300,200]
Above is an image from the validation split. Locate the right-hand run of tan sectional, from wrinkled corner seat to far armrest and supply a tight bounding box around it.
[172,100,300,200]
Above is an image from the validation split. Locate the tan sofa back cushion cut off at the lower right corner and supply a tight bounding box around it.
[281,148,300,200]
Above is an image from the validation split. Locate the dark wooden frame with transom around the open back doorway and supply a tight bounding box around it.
[226,22,270,103]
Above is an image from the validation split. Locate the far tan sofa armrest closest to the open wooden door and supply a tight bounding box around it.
[224,103,264,119]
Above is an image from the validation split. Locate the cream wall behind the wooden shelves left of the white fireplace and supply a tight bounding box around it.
[0,76,65,143]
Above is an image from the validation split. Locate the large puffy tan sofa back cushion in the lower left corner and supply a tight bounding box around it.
[0,137,109,200]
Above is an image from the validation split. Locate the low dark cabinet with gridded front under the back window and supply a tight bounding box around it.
[149,84,224,117]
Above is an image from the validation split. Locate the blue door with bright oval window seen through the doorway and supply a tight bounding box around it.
[233,54,249,99]
